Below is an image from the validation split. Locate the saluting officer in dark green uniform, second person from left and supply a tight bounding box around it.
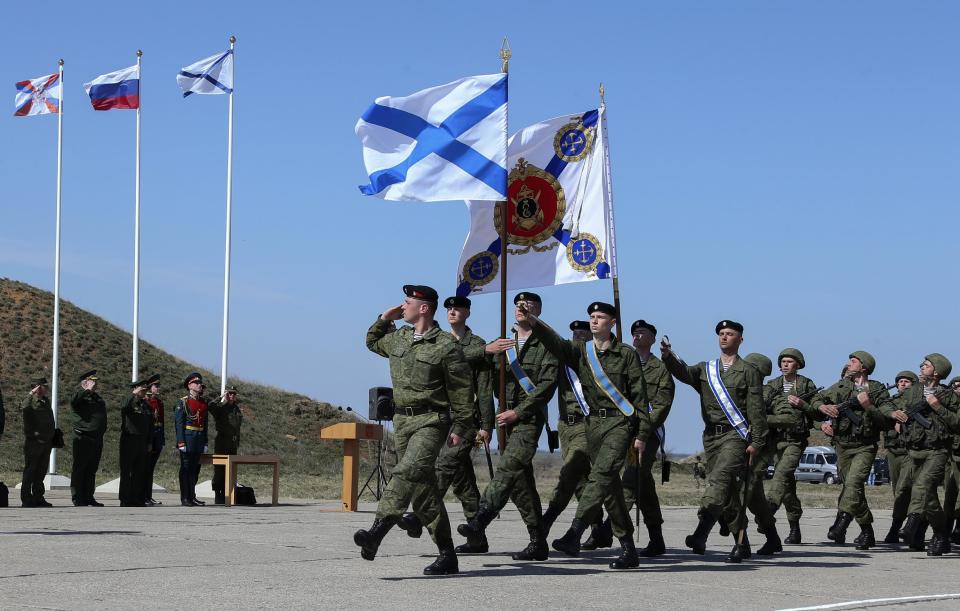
[70,369,107,507]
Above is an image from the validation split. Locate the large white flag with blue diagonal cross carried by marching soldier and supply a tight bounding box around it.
[356,74,507,202]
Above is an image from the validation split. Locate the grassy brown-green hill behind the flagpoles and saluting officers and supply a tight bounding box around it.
[0,278,372,502]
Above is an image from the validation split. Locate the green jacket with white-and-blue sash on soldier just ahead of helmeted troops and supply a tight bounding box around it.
[663,353,767,450]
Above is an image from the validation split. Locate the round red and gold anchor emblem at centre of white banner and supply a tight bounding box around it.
[494,158,567,246]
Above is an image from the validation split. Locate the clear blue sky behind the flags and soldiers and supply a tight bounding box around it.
[0,1,960,451]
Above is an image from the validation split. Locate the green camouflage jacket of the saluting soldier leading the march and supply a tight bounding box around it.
[367,318,473,436]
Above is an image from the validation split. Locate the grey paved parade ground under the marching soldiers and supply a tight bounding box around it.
[0,491,960,609]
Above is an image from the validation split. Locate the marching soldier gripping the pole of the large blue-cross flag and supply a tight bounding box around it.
[457,292,559,560]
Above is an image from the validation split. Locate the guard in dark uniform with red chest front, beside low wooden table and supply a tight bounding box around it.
[173,372,208,507]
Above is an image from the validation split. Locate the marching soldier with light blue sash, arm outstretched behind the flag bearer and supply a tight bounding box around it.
[518,301,651,569]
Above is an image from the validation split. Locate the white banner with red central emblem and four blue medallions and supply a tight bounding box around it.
[457,108,615,296]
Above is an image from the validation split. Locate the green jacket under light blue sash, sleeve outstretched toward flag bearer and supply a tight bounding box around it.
[533,323,655,439]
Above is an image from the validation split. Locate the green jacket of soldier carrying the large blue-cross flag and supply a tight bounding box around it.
[494,332,563,423]
